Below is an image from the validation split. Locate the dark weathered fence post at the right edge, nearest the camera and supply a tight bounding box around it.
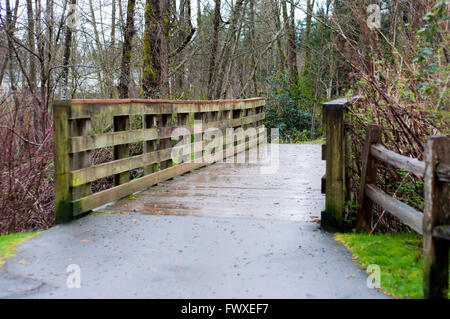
[422,136,450,299]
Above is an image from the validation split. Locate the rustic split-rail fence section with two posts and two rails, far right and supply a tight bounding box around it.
[356,125,450,298]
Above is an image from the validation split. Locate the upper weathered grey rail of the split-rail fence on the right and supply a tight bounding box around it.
[370,144,425,177]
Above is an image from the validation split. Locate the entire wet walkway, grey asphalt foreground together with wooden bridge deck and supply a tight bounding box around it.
[0,144,386,298]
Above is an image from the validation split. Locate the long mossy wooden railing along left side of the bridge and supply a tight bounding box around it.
[53,98,265,223]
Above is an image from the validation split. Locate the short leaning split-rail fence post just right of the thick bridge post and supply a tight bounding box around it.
[356,124,381,233]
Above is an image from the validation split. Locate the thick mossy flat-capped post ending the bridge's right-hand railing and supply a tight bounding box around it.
[321,99,347,229]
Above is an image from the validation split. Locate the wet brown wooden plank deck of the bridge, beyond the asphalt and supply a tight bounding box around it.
[100,144,325,220]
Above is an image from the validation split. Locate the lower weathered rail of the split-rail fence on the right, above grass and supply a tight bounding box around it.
[364,184,423,234]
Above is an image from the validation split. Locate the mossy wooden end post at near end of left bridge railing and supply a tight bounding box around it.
[53,101,72,224]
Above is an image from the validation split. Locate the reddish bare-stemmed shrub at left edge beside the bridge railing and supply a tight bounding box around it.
[0,91,54,234]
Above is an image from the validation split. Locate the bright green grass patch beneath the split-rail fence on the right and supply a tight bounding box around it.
[334,233,450,298]
